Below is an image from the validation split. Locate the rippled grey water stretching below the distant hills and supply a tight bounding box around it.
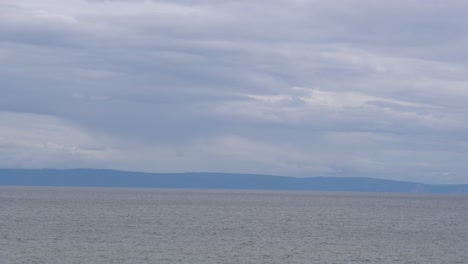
[0,187,468,264]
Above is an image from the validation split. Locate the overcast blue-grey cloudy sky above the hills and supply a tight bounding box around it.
[0,0,468,183]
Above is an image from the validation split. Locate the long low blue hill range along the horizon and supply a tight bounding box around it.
[0,169,468,194]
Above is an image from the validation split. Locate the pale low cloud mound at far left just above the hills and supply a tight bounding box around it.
[0,112,110,167]
